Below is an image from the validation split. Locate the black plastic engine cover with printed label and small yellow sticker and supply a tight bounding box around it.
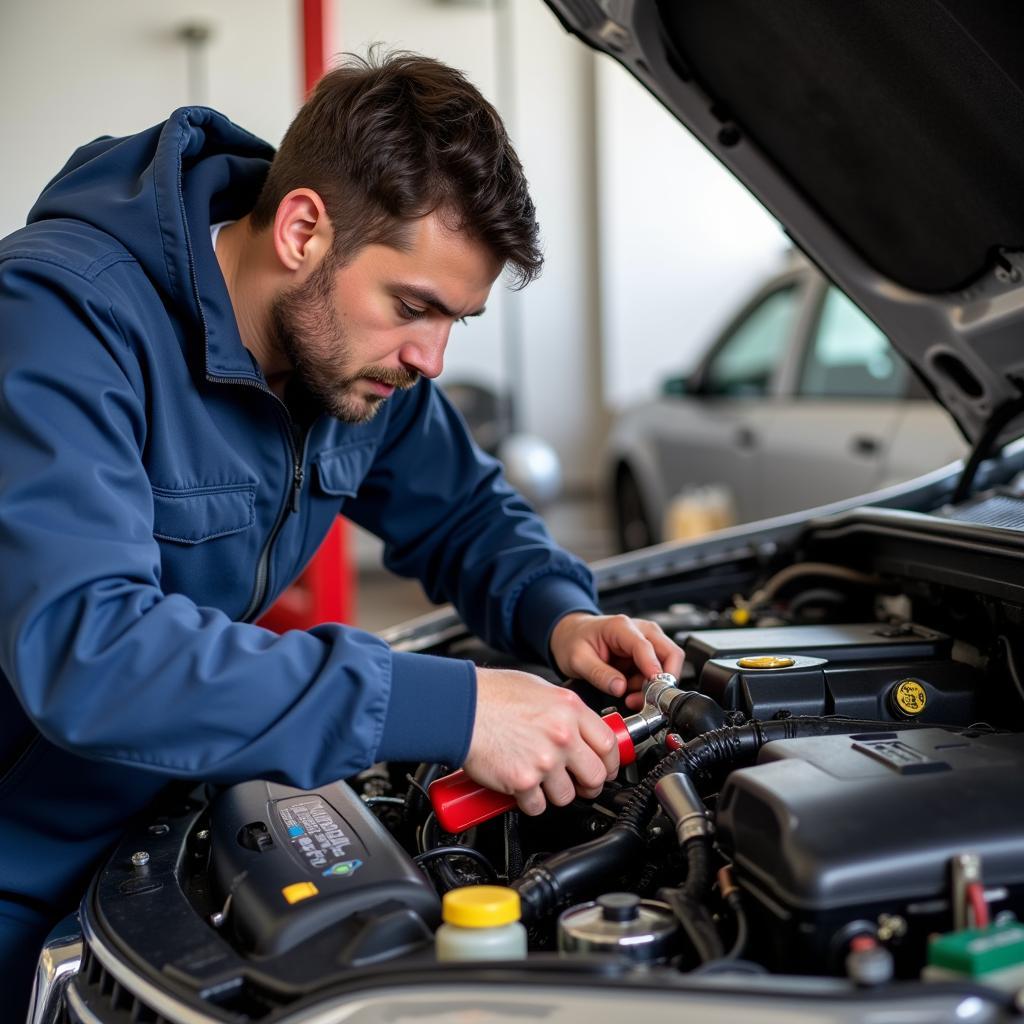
[210,780,440,955]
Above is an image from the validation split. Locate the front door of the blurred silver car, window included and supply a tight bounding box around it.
[650,274,805,521]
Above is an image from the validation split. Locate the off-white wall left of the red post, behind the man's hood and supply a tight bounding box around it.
[0,0,302,234]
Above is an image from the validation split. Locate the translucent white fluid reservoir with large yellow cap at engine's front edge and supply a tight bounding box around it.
[435,886,526,961]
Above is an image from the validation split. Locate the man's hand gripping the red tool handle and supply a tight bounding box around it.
[463,669,618,814]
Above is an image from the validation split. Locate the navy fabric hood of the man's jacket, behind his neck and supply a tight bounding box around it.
[29,106,273,327]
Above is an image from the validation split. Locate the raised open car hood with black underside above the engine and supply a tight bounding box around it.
[546,0,1024,443]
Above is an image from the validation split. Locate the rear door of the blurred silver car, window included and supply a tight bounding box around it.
[758,283,913,515]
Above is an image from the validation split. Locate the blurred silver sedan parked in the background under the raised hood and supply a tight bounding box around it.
[607,260,967,551]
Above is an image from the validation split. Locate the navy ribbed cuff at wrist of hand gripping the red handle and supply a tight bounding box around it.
[375,651,476,768]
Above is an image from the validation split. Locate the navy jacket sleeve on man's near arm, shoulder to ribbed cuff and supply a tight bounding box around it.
[0,259,475,787]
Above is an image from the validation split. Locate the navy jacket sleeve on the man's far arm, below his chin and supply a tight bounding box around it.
[343,380,598,663]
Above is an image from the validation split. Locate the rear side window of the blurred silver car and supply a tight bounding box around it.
[798,288,910,398]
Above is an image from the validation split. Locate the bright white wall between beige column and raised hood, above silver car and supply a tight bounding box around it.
[597,56,788,408]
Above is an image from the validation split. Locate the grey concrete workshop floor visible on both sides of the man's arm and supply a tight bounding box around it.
[355,499,614,632]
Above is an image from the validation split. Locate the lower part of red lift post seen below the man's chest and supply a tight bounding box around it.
[259,518,355,633]
